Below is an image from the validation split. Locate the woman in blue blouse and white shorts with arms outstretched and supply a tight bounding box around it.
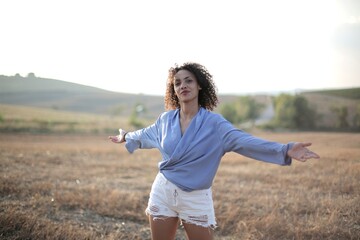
[109,63,319,240]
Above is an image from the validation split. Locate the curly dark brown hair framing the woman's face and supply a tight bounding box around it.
[164,62,219,111]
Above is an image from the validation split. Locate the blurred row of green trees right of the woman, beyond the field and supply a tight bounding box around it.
[220,94,360,131]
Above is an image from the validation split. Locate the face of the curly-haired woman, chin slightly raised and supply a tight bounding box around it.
[174,70,201,102]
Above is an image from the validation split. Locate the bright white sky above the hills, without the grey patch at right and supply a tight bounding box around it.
[0,0,360,95]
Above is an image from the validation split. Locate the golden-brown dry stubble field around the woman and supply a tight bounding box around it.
[0,132,360,240]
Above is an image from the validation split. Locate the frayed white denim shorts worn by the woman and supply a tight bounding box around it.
[145,173,216,228]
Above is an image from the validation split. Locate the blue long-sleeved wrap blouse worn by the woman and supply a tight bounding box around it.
[125,108,293,192]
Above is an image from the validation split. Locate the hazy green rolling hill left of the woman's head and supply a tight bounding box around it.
[0,75,164,118]
